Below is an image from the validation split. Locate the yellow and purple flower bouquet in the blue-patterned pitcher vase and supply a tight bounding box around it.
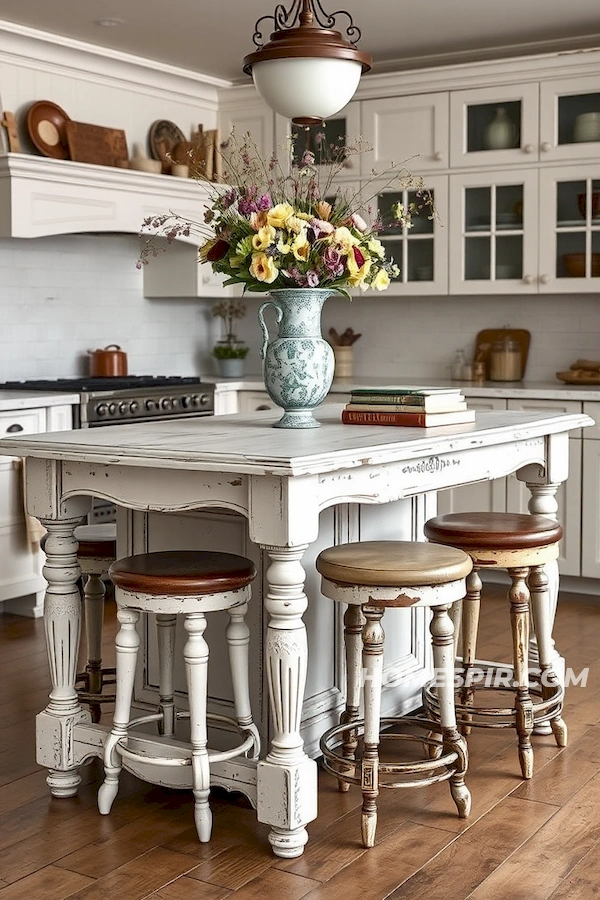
[138,133,435,296]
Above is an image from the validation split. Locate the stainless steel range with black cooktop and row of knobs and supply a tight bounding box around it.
[0,375,215,428]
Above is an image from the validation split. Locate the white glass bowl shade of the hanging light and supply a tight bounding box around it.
[252,56,362,119]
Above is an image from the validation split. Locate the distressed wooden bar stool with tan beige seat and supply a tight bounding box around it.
[316,541,472,847]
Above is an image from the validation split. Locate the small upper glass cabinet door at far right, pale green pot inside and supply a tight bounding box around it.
[540,75,600,161]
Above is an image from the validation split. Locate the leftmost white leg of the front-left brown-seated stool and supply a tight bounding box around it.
[98,607,140,816]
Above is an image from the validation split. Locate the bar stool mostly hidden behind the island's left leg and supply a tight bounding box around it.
[75,522,117,722]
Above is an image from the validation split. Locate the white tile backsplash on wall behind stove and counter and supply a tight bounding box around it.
[0,235,600,380]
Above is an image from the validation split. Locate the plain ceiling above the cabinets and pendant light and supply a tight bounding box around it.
[0,0,600,81]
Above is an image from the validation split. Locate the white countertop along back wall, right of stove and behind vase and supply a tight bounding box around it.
[209,375,600,402]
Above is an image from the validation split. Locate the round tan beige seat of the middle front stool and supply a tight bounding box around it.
[317,541,472,587]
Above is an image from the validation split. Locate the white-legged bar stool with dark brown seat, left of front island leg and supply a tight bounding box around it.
[98,551,260,842]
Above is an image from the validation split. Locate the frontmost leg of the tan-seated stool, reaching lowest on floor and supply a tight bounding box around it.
[360,606,385,847]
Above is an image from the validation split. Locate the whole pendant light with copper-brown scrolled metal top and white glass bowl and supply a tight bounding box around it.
[244,0,372,126]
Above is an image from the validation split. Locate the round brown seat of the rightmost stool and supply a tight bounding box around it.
[424,512,563,550]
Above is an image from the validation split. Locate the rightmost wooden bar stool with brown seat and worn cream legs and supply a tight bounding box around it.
[423,512,567,778]
